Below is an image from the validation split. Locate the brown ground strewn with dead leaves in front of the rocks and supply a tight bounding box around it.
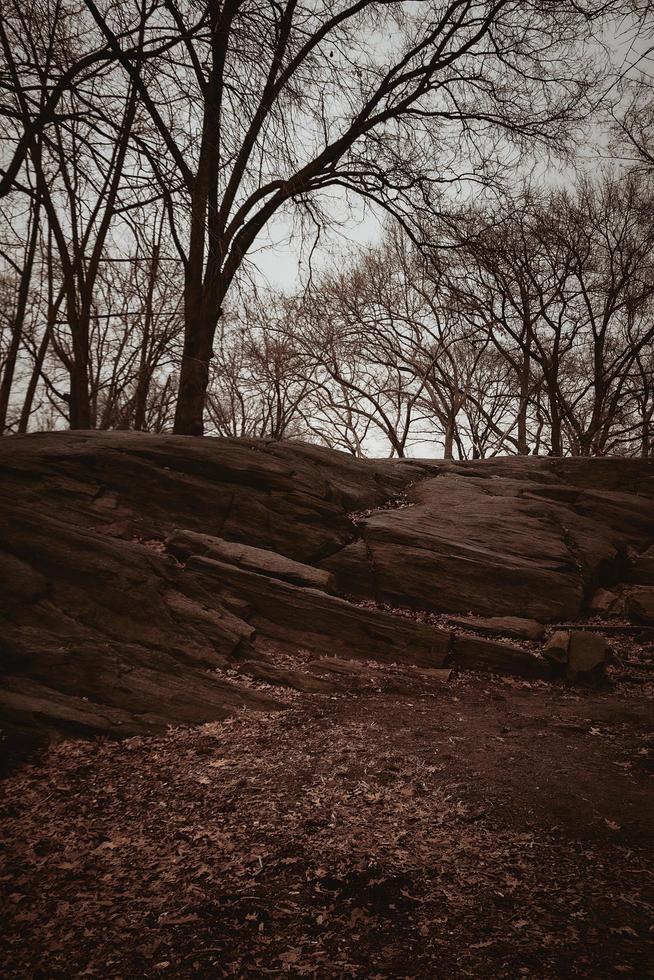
[0,671,654,980]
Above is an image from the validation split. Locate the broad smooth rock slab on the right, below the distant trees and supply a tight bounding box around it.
[321,458,654,622]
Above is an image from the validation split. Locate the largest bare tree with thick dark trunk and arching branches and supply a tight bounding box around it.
[75,0,610,434]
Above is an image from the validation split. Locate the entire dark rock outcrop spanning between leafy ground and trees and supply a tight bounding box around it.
[0,432,654,752]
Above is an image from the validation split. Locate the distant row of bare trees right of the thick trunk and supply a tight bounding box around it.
[208,174,654,458]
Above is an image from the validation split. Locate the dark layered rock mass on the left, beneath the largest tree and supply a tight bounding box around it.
[0,432,422,752]
